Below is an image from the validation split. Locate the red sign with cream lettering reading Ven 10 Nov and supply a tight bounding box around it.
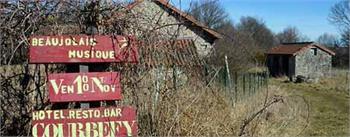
[48,72,121,102]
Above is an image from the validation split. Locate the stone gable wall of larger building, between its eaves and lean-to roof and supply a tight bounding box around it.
[132,0,212,57]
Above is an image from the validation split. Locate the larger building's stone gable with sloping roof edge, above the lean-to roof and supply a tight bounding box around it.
[127,0,221,58]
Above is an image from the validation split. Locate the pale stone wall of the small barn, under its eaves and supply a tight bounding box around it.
[295,48,332,78]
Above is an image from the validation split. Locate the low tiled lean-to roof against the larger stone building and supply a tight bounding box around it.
[139,39,203,67]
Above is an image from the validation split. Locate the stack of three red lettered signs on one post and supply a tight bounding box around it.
[29,35,138,137]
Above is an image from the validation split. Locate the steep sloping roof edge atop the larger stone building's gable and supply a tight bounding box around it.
[127,0,222,39]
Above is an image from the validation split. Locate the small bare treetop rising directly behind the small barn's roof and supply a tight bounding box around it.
[276,27,308,43]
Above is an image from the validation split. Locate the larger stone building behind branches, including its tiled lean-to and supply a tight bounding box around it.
[117,0,221,93]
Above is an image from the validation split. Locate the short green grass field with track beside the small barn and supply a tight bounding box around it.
[270,70,350,136]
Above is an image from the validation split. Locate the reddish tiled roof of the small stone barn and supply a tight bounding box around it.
[266,42,335,56]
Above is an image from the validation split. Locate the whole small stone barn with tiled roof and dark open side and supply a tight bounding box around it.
[266,42,335,80]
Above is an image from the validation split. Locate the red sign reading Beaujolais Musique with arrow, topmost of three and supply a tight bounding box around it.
[29,35,138,63]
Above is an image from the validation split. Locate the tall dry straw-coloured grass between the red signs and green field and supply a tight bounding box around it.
[134,81,308,136]
